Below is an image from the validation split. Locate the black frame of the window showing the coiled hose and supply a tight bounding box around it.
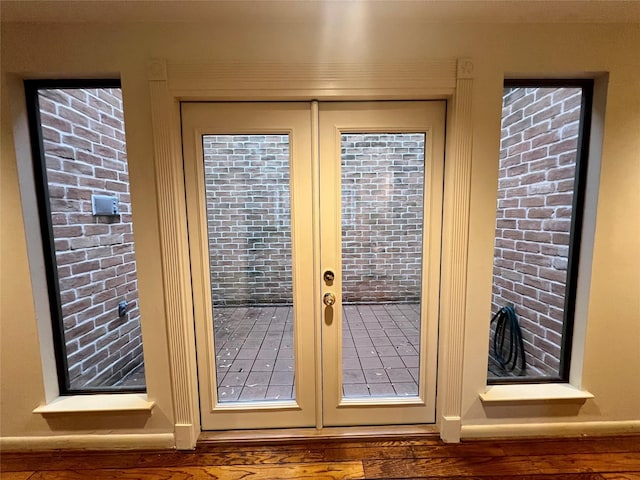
[487,78,595,386]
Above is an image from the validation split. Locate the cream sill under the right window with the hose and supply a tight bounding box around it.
[480,383,593,403]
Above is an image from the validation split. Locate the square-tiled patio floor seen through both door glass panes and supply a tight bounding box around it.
[214,303,420,402]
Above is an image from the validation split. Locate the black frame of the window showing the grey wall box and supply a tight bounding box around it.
[24,78,147,396]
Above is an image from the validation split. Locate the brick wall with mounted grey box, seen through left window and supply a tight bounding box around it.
[39,89,143,388]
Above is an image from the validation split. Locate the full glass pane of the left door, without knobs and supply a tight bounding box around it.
[203,135,295,403]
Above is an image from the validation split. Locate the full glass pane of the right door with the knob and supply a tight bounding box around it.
[341,133,425,397]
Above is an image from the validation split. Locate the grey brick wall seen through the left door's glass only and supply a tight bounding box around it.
[203,135,293,305]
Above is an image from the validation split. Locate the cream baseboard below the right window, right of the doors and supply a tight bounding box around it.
[461,420,640,439]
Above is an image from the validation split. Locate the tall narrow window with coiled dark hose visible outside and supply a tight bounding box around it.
[488,80,593,384]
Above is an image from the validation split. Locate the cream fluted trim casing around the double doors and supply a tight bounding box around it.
[148,59,473,449]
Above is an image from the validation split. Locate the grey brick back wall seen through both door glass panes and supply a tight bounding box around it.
[203,134,424,305]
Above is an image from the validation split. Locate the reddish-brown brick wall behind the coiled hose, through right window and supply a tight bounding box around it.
[492,88,581,375]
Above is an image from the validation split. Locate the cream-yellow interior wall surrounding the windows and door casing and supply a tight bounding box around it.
[0,7,640,442]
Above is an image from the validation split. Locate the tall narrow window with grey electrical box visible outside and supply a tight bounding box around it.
[25,80,145,394]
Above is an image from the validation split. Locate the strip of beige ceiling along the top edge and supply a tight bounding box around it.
[0,0,640,25]
